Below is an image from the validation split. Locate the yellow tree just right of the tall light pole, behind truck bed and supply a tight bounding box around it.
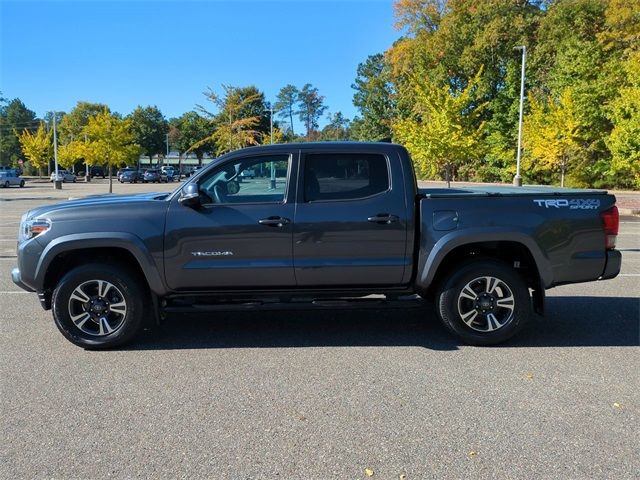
[523,88,581,187]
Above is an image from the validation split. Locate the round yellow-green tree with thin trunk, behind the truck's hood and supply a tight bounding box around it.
[83,110,141,193]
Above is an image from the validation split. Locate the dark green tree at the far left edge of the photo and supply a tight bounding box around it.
[0,98,38,166]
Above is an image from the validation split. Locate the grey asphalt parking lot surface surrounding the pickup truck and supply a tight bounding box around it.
[0,180,640,479]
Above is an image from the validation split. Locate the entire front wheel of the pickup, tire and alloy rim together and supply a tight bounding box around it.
[52,263,146,349]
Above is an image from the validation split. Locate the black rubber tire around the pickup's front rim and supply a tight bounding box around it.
[52,263,147,350]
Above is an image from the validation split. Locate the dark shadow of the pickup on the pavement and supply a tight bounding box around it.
[125,297,640,350]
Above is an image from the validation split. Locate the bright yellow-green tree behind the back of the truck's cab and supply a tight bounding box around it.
[392,71,485,185]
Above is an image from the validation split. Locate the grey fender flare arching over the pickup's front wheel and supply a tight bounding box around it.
[34,232,167,295]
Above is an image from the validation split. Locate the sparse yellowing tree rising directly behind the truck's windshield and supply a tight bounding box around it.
[196,85,268,155]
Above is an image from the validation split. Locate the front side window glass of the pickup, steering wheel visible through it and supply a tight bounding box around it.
[199,154,291,203]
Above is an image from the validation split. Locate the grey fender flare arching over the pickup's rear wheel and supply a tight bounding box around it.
[417,227,553,289]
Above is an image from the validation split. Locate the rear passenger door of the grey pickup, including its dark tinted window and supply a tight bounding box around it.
[293,150,412,287]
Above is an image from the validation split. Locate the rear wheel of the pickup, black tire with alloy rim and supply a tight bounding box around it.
[436,260,531,345]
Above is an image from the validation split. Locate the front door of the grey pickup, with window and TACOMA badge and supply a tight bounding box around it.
[165,153,296,290]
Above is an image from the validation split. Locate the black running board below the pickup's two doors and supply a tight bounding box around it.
[162,295,425,313]
